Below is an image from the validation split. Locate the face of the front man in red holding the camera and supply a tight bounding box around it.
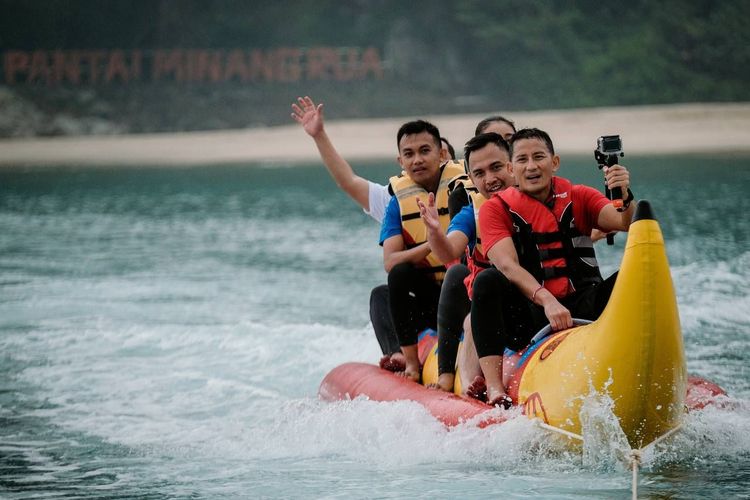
[511,138,560,202]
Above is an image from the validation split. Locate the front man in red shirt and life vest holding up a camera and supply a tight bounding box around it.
[471,129,634,408]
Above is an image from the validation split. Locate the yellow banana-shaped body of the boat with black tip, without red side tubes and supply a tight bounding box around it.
[423,202,687,448]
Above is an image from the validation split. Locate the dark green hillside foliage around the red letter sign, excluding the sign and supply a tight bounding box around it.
[0,0,750,135]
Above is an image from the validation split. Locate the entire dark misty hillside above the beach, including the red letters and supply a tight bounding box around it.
[0,0,750,137]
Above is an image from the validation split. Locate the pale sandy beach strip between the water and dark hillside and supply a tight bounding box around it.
[0,103,750,168]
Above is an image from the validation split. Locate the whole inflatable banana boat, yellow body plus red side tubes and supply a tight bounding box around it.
[319,201,724,448]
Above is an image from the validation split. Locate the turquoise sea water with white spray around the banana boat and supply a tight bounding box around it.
[0,157,750,499]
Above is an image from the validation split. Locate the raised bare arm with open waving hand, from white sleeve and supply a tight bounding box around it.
[292,96,370,212]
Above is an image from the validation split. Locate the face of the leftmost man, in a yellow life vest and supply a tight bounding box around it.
[398,132,441,192]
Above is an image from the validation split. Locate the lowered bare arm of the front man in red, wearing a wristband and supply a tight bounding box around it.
[487,237,573,331]
